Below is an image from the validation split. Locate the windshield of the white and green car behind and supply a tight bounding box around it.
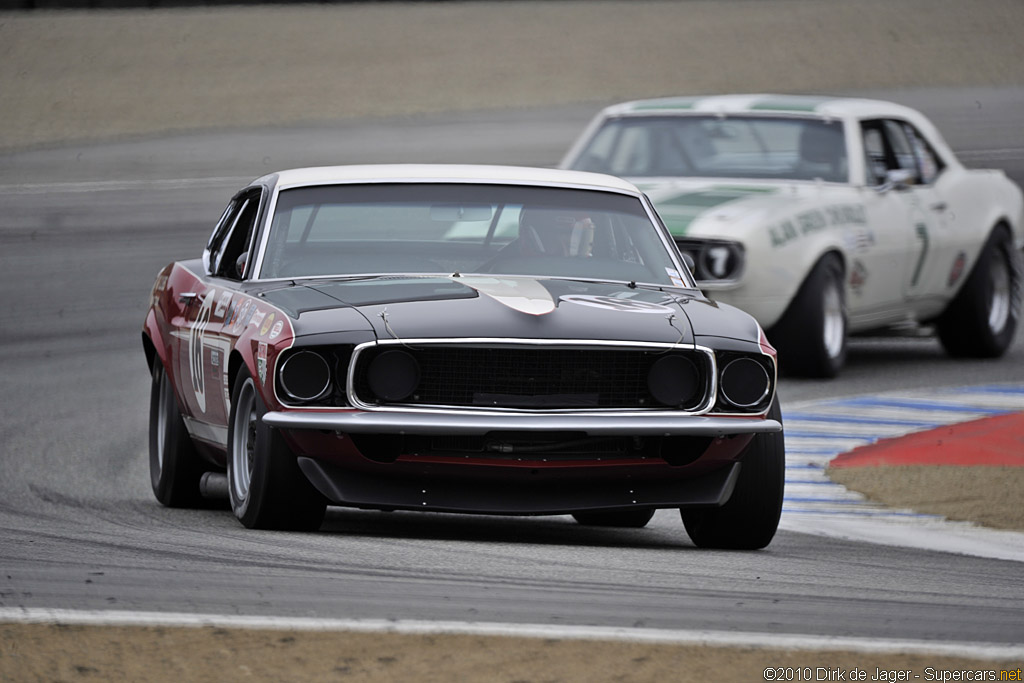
[569,115,848,182]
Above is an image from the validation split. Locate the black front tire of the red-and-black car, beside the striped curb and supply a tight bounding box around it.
[680,398,785,550]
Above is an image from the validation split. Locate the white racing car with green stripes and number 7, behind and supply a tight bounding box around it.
[561,94,1024,377]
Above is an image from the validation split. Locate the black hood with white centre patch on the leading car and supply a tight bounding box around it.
[264,275,757,344]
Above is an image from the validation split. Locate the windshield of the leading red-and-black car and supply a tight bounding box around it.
[259,183,685,287]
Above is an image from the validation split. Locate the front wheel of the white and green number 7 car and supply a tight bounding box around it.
[767,254,847,378]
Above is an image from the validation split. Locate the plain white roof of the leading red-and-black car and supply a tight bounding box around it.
[254,164,640,195]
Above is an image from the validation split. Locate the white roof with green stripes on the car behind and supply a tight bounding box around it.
[602,93,920,119]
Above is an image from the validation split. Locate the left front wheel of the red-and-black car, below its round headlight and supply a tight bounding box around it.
[227,366,327,531]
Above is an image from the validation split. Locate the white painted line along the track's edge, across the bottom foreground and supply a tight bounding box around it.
[0,607,1024,659]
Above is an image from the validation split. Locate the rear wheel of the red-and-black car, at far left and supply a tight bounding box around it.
[150,358,207,508]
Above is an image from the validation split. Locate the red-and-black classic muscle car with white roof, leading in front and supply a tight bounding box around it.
[142,166,784,549]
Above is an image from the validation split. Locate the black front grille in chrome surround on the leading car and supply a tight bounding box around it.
[353,343,711,411]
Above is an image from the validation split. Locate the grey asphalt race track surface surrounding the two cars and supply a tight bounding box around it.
[0,88,1024,645]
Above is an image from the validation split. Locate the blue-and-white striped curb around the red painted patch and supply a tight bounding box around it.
[781,384,1024,561]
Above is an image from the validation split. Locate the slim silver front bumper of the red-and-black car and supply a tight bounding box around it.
[263,411,782,437]
